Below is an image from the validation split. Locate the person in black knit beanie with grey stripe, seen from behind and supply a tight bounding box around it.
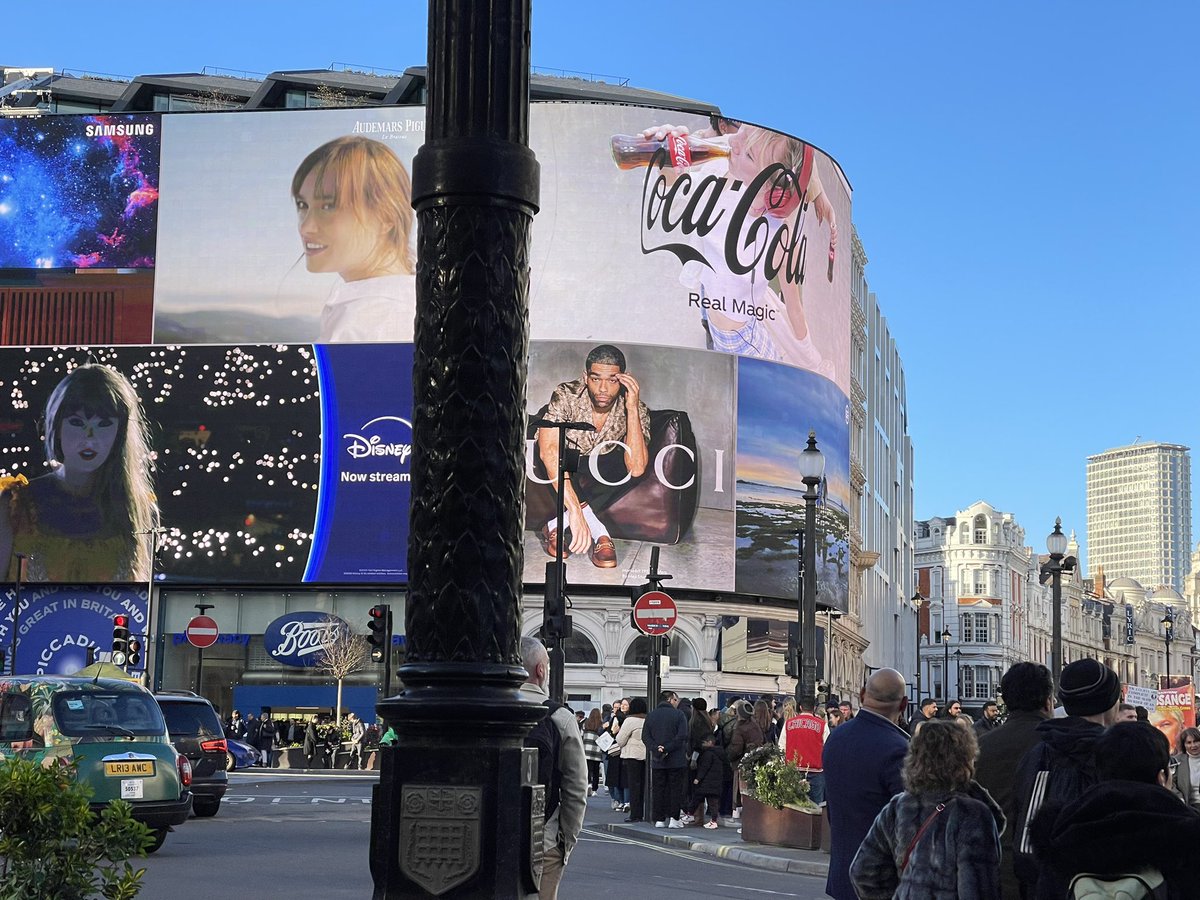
[1012,659,1121,900]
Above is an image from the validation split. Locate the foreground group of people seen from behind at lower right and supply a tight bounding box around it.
[823,659,1200,900]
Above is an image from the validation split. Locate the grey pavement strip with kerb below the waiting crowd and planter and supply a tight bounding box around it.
[584,787,829,878]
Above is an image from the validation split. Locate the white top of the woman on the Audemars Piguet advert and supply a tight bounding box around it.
[318,275,416,343]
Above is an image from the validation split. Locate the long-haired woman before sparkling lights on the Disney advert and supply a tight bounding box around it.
[0,364,158,582]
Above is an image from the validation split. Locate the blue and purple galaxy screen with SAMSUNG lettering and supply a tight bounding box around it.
[0,115,161,269]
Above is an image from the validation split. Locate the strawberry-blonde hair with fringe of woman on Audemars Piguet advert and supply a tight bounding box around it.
[292,134,415,275]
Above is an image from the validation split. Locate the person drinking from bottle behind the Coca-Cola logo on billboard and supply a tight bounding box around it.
[642,119,838,378]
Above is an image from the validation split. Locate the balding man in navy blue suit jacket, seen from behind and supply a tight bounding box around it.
[823,668,908,900]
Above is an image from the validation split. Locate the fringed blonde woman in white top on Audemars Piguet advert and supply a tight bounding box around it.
[292,136,416,343]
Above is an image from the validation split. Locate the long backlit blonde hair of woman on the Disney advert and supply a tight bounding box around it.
[44,362,158,581]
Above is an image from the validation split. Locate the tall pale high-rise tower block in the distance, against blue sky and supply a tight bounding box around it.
[1087,443,1192,592]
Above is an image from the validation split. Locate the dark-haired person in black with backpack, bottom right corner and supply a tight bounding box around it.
[1032,721,1200,900]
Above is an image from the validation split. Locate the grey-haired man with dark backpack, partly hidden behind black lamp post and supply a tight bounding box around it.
[521,637,588,900]
